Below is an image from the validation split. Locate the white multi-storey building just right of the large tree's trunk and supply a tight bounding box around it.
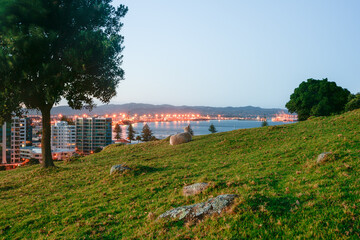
[51,121,76,150]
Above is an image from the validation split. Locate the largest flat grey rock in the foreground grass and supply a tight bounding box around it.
[159,194,238,221]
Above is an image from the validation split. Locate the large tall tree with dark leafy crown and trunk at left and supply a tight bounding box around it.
[0,0,128,167]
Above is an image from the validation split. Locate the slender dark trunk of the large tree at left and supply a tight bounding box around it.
[41,106,55,168]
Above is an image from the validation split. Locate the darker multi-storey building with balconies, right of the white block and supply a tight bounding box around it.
[75,117,112,155]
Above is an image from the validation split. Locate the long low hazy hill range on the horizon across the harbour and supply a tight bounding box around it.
[26,103,287,117]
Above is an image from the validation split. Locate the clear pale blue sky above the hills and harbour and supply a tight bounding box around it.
[111,0,360,108]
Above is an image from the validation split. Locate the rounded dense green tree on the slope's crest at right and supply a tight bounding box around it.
[286,78,350,121]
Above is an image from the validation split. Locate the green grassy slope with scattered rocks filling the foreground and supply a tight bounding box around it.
[0,111,360,239]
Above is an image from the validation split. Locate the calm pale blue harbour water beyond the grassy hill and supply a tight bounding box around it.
[116,120,289,139]
